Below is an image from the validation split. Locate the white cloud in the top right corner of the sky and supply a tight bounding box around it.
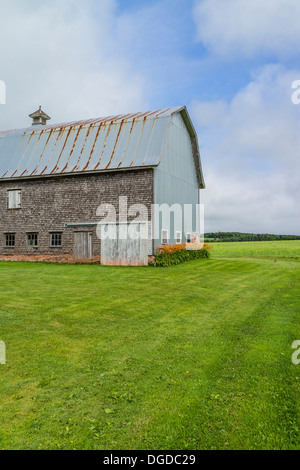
[194,0,300,59]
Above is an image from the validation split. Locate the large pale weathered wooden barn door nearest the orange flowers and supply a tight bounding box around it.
[101,222,148,266]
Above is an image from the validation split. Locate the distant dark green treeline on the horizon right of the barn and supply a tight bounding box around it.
[204,232,300,243]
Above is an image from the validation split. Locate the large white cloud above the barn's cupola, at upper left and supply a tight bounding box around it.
[0,0,147,130]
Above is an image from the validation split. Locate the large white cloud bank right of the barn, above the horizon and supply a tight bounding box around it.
[191,65,300,234]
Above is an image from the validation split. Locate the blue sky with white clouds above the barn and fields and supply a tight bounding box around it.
[0,0,300,235]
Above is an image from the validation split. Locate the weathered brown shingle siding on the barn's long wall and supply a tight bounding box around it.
[0,169,153,256]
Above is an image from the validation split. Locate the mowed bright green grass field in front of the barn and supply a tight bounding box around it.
[0,242,300,450]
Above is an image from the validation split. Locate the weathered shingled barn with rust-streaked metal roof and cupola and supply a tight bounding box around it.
[0,106,205,265]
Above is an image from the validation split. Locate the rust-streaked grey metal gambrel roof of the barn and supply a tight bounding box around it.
[0,106,205,188]
